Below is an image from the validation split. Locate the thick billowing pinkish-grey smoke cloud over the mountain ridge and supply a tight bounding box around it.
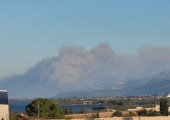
[24,43,170,92]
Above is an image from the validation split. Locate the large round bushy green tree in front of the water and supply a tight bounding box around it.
[26,98,65,119]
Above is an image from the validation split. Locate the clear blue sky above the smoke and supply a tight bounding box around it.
[0,0,170,78]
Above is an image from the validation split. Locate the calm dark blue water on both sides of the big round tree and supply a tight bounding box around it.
[9,101,93,113]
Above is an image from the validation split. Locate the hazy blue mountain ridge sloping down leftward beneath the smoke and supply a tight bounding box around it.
[55,71,170,97]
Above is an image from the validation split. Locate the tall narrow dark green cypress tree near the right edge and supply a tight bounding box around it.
[160,98,168,116]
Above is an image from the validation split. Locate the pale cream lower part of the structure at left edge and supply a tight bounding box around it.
[0,104,9,120]
